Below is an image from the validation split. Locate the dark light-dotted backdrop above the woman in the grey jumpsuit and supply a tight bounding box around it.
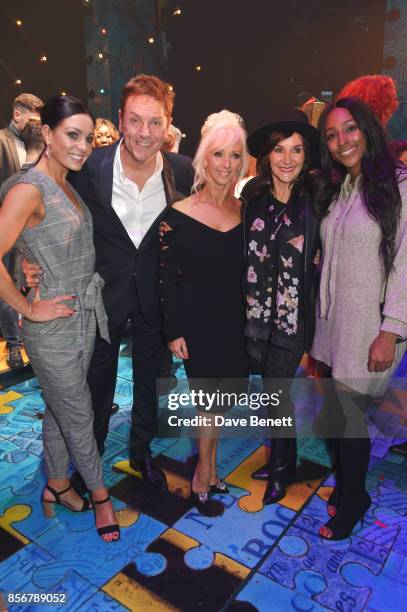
[0,0,87,127]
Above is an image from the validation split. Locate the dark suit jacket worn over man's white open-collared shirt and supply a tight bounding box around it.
[68,143,193,325]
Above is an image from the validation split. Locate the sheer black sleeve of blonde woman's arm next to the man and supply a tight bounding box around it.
[158,229,182,342]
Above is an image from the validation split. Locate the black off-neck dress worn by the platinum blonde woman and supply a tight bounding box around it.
[159,208,249,379]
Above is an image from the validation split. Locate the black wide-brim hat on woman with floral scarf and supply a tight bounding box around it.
[247,108,319,168]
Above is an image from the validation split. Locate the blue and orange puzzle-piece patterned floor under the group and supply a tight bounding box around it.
[0,351,407,612]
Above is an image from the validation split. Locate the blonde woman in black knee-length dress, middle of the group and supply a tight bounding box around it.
[159,110,249,514]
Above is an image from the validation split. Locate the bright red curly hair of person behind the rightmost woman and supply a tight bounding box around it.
[336,74,399,127]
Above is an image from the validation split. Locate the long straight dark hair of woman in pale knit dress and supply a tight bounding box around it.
[312,96,401,275]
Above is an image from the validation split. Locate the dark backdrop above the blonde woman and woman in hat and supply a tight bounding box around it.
[167,0,386,154]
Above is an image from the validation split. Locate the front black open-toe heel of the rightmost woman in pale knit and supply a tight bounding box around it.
[319,491,372,540]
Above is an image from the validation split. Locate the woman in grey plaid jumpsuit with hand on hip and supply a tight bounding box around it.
[0,96,120,541]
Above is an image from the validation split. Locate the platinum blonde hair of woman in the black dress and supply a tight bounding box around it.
[192,110,249,193]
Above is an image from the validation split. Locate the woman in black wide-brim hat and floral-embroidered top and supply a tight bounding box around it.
[242,109,319,504]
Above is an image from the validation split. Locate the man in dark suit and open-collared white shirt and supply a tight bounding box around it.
[27,75,193,491]
